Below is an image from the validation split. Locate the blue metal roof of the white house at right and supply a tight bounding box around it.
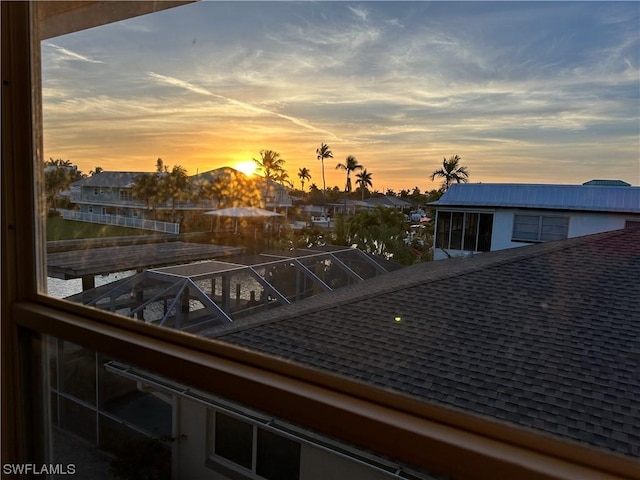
[430,183,640,213]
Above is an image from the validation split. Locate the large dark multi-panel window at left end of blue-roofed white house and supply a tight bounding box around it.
[436,211,493,252]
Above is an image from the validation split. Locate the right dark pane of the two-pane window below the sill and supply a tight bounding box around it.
[256,429,300,480]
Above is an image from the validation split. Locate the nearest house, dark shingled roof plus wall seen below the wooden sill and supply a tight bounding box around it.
[56,226,640,480]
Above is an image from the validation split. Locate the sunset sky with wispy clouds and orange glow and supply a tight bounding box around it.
[42,1,640,192]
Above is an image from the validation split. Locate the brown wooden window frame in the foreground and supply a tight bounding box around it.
[0,2,638,480]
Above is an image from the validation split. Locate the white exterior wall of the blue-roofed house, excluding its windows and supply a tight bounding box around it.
[433,208,640,260]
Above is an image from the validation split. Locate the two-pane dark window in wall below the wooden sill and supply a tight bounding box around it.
[212,411,300,480]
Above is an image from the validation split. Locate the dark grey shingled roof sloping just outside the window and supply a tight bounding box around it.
[209,228,640,457]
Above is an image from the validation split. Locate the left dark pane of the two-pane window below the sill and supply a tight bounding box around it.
[215,412,253,469]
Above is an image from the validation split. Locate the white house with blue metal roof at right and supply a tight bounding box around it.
[429,180,640,260]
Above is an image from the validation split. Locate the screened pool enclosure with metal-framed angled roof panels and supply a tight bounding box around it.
[68,247,399,334]
